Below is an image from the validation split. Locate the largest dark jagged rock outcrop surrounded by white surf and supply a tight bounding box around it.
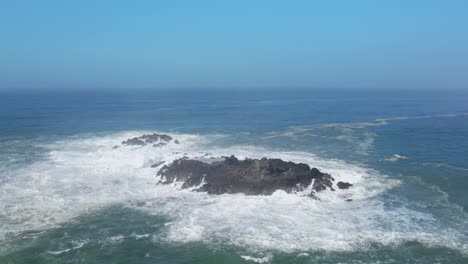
[158,156,348,196]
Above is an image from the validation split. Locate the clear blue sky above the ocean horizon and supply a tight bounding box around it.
[0,0,468,90]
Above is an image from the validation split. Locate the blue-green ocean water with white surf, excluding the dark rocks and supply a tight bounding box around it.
[0,90,468,263]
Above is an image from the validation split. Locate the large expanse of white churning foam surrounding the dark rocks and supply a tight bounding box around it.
[0,131,467,253]
